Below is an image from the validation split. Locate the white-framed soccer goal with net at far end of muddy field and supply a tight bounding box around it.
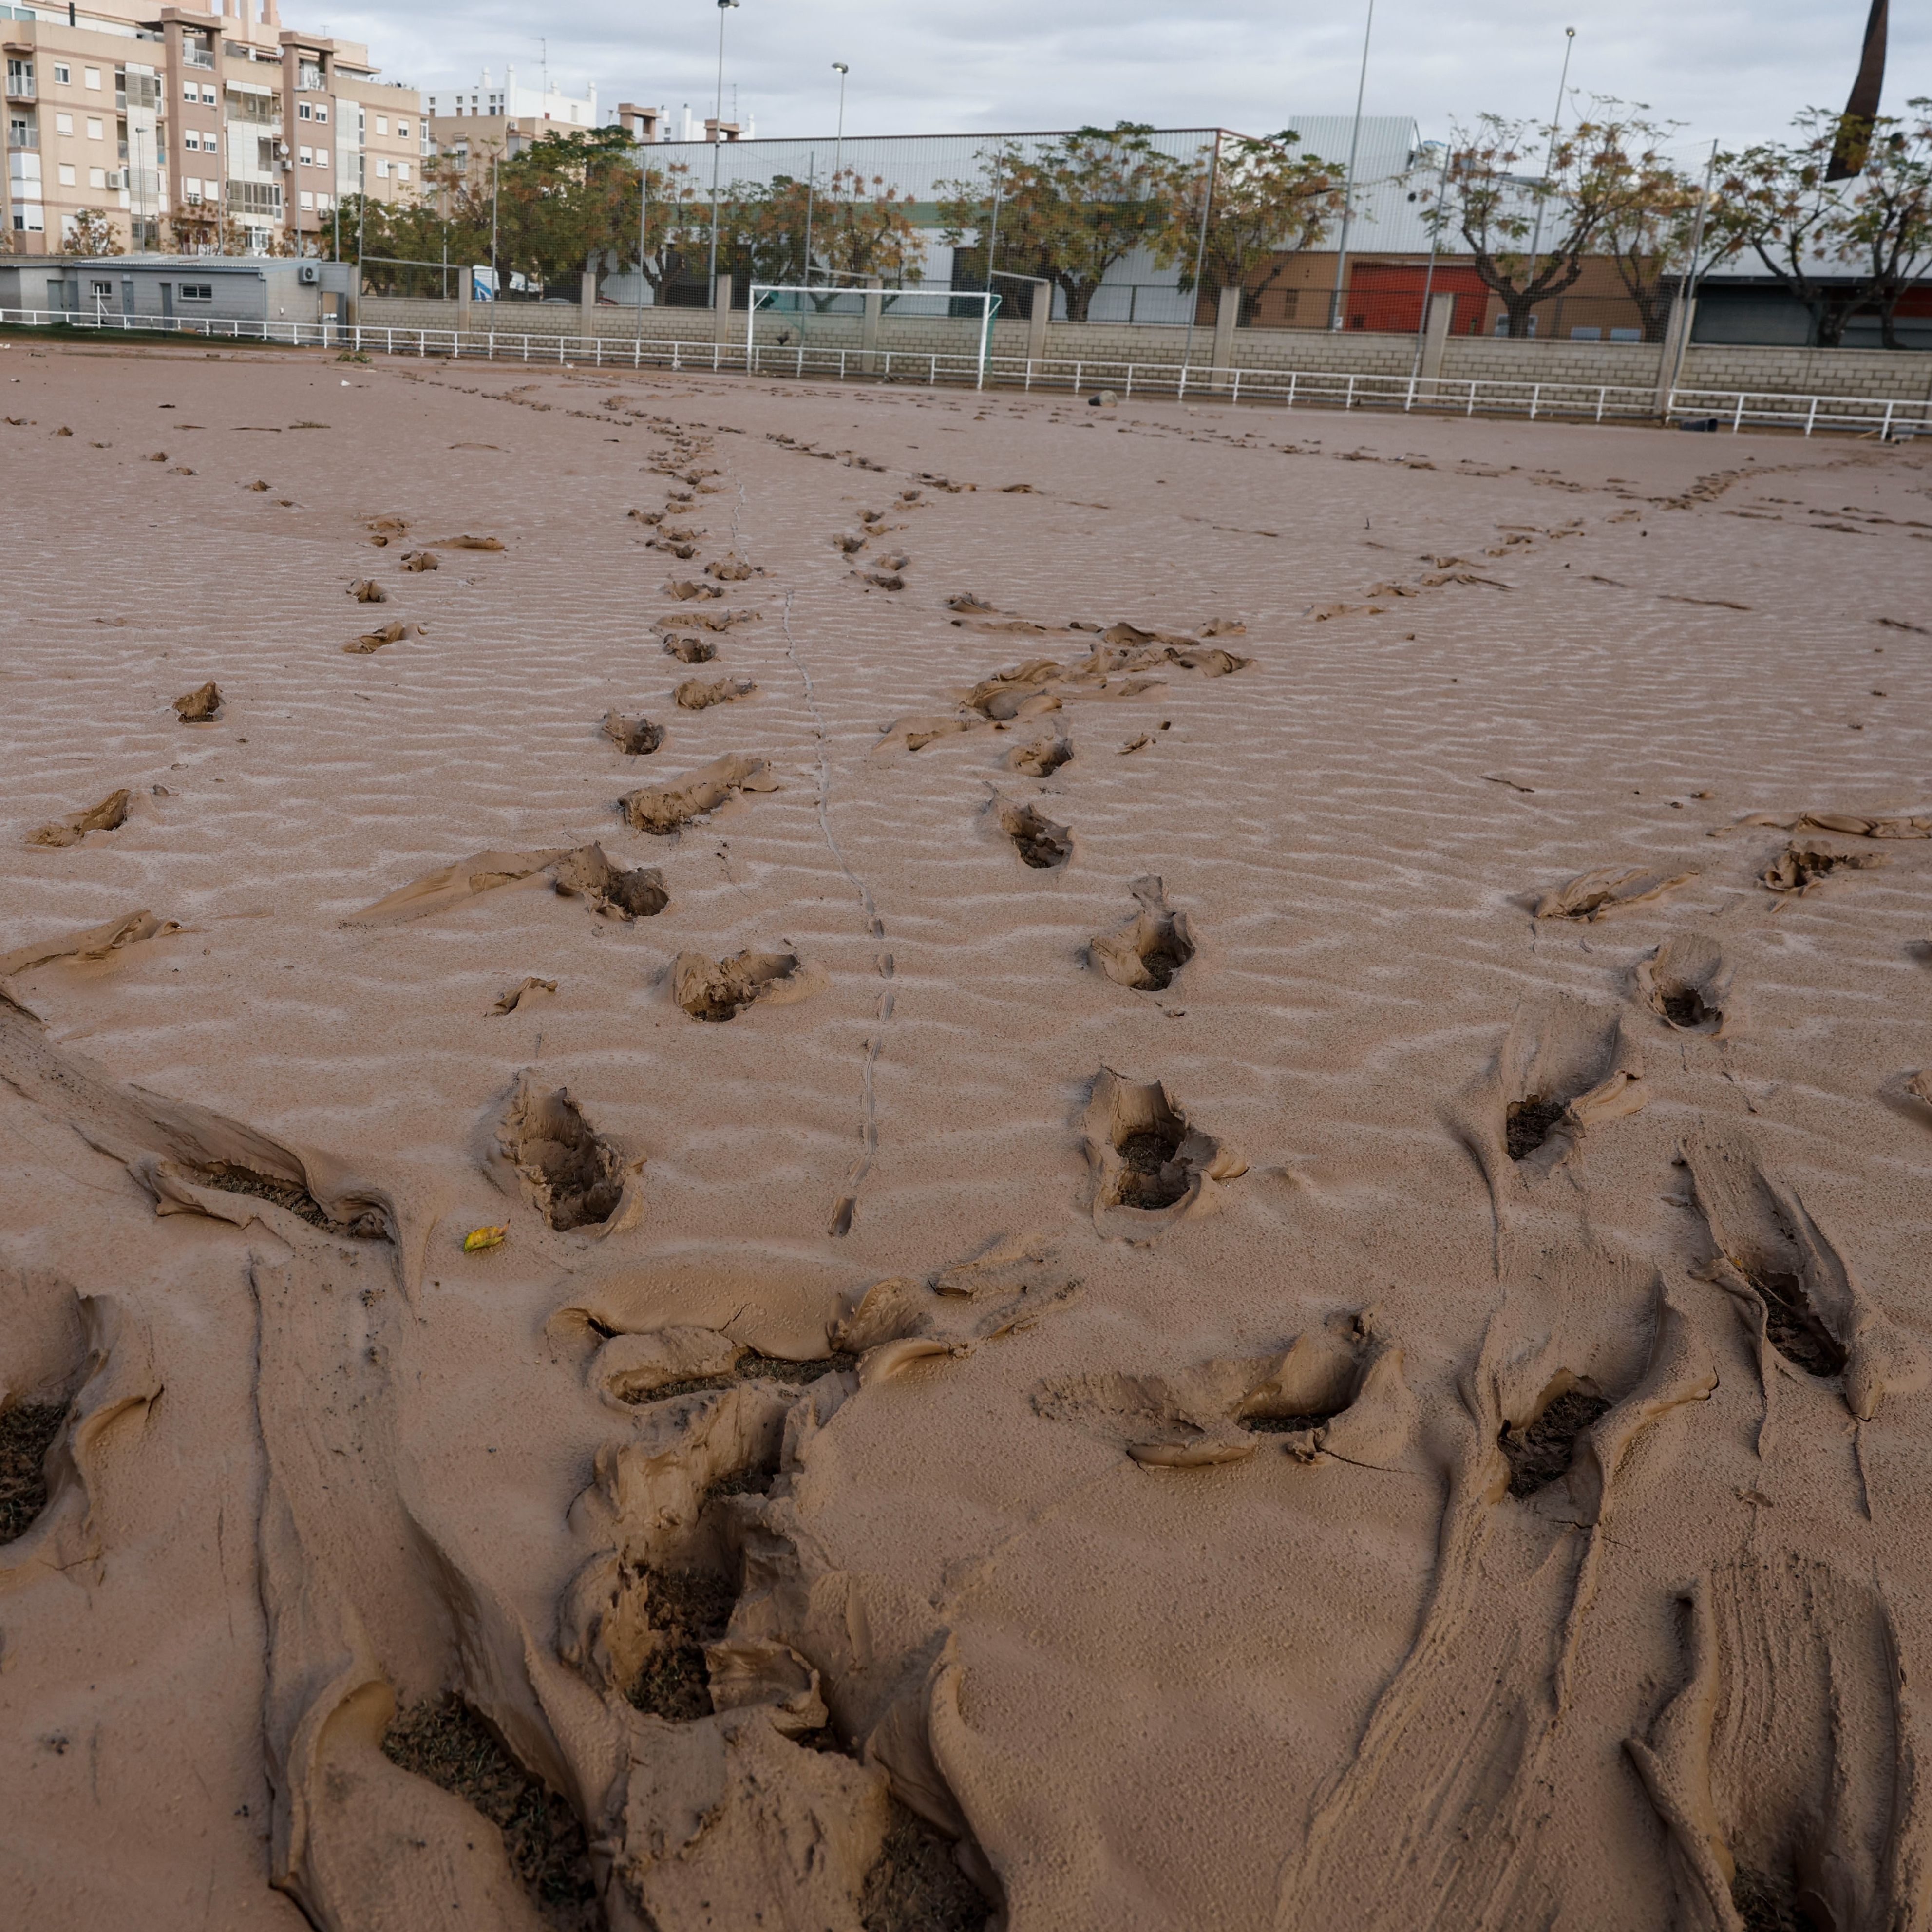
[744,282,999,388]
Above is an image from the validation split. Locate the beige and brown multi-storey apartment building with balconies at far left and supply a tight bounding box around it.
[0,0,429,255]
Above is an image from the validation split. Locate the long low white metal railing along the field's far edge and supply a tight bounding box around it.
[0,307,1932,438]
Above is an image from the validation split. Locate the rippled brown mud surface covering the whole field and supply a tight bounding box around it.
[0,342,1932,1932]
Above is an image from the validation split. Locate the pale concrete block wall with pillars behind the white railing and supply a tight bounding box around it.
[361,296,1932,402]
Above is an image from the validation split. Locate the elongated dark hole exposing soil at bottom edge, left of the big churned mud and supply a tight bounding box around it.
[382,1696,605,1932]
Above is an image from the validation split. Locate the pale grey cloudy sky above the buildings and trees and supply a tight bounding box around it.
[324,0,1932,152]
